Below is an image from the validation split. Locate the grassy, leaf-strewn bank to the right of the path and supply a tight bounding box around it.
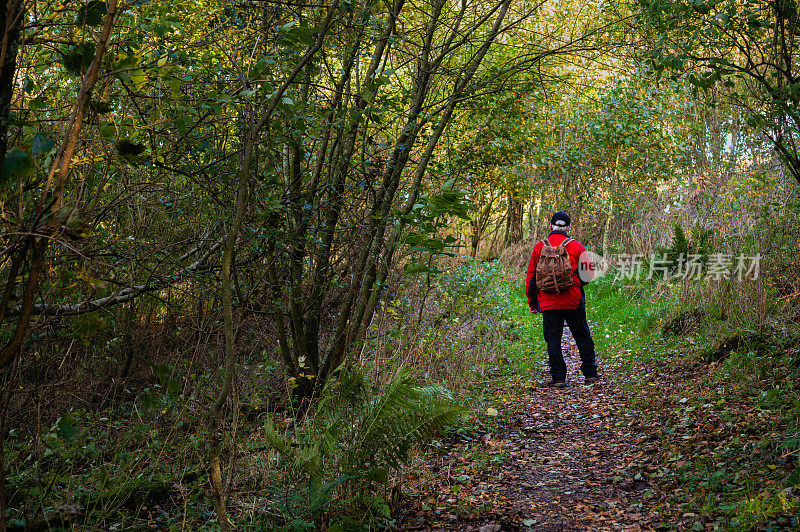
[587,272,800,530]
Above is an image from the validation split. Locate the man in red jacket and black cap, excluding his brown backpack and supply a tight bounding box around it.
[525,212,598,388]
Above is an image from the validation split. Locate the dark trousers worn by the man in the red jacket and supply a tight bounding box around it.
[542,308,597,381]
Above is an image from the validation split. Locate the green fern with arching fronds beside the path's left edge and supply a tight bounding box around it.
[264,370,460,519]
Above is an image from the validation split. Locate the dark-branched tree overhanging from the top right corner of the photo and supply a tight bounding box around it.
[639,0,800,183]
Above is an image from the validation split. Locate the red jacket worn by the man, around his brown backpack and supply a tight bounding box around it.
[525,231,586,310]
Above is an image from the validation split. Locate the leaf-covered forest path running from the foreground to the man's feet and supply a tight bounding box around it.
[394,329,664,532]
